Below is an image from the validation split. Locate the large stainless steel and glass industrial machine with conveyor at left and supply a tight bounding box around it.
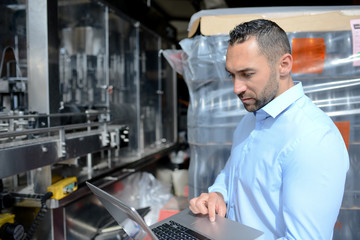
[0,0,177,240]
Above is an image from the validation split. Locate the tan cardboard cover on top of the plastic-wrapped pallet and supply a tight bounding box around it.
[188,5,360,38]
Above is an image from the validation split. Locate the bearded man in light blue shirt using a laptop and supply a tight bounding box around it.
[190,19,349,240]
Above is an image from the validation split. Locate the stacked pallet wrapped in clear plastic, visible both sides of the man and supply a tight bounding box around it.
[167,28,360,239]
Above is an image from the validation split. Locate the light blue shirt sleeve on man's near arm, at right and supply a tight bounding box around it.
[280,126,349,240]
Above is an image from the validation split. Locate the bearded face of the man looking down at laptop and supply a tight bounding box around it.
[226,38,279,112]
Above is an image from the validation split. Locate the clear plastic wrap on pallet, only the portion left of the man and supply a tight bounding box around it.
[164,35,246,198]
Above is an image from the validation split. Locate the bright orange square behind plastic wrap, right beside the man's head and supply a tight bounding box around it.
[292,38,326,73]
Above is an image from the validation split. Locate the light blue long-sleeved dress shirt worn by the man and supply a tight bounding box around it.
[209,82,349,240]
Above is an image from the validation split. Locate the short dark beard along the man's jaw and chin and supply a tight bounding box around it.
[239,69,279,112]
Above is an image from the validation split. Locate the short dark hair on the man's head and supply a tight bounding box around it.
[229,19,291,64]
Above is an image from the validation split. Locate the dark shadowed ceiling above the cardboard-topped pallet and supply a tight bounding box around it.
[106,0,360,42]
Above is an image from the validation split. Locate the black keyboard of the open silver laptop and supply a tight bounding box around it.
[152,221,208,240]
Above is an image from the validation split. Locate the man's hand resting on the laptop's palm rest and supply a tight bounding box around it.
[189,192,226,222]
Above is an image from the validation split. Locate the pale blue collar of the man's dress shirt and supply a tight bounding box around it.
[256,81,304,118]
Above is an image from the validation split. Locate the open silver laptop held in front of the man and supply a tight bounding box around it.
[86,182,263,240]
